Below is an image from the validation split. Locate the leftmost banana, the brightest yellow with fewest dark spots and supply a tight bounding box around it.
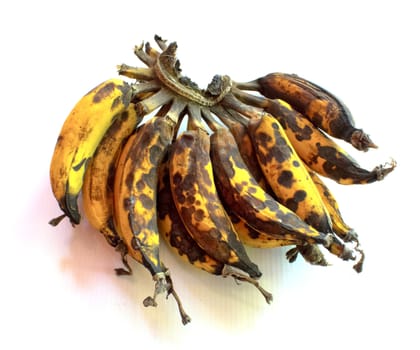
[50,79,132,224]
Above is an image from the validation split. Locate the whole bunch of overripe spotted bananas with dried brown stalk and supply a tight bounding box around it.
[50,36,395,324]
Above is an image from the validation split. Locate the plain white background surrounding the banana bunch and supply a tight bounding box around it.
[0,0,420,350]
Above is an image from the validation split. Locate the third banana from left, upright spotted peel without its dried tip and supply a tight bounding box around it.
[119,117,173,274]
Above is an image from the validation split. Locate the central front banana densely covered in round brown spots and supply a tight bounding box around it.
[169,129,261,278]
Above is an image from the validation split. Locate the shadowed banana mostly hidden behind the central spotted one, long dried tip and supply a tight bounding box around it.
[157,157,273,303]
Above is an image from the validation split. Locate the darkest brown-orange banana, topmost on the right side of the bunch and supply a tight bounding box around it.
[235,73,376,151]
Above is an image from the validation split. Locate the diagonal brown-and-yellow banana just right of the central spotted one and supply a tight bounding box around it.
[211,130,324,242]
